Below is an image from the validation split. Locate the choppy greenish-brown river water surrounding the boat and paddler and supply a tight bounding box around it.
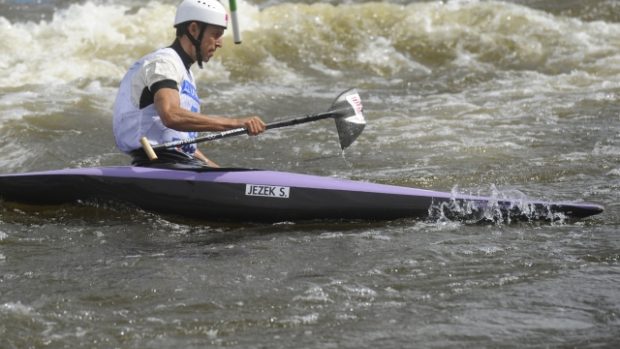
[0,0,620,349]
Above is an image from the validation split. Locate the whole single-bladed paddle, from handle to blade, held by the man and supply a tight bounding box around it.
[140,88,366,160]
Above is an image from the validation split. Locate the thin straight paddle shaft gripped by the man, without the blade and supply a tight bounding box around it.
[148,108,349,152]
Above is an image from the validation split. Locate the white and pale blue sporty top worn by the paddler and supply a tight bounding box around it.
[112,47,200,155]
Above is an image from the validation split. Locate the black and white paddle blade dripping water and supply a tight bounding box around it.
[329,88,366,150]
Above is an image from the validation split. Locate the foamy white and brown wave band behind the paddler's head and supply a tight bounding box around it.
[0,1,620,88]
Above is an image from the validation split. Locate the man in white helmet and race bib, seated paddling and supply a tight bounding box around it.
[113,0,265,167]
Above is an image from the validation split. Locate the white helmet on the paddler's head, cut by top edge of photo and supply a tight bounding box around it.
[174,0,228,28]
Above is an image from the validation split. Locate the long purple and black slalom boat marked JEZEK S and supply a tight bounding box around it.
[0,166,603,222]
